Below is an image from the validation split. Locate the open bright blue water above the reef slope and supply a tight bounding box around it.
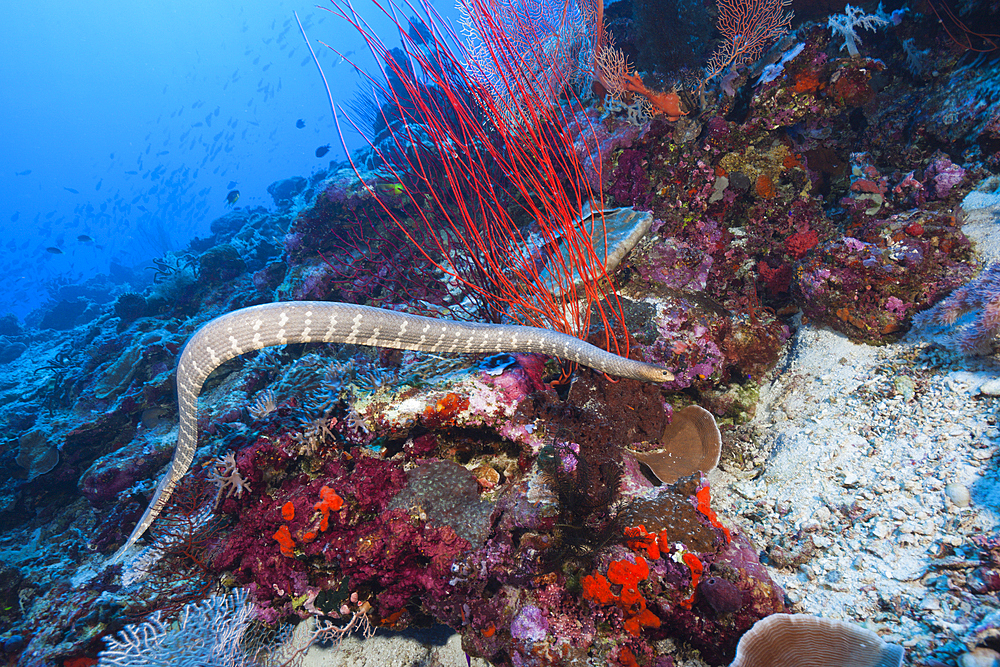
[0,0,458,318]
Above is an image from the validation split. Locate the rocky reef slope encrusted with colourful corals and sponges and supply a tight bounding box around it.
[0,0,1000,667]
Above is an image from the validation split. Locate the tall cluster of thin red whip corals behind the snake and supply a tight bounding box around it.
[330,0,627,353]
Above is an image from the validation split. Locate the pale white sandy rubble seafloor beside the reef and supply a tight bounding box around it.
[278,184,1000,667]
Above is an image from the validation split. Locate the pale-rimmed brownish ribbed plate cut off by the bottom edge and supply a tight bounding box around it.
[730,614,903,667]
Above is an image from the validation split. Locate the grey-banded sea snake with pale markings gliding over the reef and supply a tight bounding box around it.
[110,301,674,563]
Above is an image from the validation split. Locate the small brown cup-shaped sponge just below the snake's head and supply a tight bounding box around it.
[632,405,722,484]
